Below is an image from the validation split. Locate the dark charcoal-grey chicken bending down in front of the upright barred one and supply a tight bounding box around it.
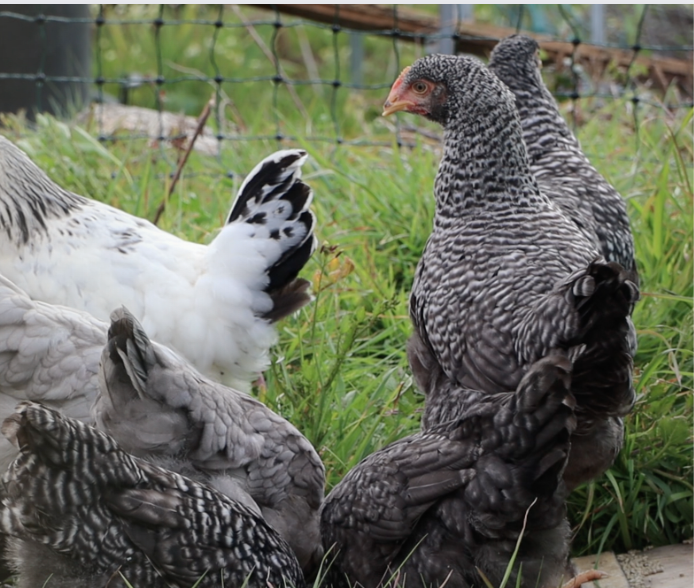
[321,355,575,588]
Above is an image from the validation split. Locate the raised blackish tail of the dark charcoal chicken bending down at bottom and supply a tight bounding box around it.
[457,354,576,529]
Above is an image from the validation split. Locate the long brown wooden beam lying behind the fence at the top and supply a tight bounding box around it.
[255,4,694,94]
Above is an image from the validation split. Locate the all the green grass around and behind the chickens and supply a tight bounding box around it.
[2,3,694,580]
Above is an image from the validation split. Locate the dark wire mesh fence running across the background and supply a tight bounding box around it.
[0,5,692,176]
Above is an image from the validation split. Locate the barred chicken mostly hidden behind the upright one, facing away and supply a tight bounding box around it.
[489,35,636,273]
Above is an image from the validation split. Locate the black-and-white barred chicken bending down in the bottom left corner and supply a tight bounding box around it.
[0,402,305,588]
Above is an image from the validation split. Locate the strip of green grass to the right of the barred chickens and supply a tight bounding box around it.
[571,104,694,552]
